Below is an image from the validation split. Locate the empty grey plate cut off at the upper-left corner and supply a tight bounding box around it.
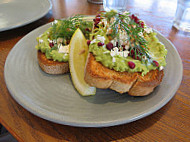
[0,0,52,32]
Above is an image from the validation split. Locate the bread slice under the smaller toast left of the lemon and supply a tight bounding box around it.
[37,51,69,74]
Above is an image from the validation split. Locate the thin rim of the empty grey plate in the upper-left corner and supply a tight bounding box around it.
[0,0,52,32]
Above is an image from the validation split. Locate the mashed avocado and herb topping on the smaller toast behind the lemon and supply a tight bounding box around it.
[35,16,92,62]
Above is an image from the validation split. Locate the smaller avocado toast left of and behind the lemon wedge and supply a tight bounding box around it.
[36,15,92,74]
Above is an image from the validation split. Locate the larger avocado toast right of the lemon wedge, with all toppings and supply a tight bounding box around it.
[84,10,167,96]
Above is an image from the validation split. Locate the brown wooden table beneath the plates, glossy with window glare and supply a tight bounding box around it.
[0,0,190,142]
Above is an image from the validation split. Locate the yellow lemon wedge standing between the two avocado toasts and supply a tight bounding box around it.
[69,29,96,96]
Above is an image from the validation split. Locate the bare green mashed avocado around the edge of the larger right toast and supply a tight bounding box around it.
[89,32,167,75]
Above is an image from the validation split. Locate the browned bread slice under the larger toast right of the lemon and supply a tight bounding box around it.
[84,53,164,96]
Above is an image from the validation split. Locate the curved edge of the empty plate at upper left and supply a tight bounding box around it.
[0,0,52,32]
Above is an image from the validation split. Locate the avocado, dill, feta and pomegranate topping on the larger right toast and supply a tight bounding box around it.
[89,11,167,75]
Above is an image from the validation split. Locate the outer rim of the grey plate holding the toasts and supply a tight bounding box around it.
[4,20,183,127]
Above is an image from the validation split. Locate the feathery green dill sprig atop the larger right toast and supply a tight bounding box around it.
[101,10,150,62]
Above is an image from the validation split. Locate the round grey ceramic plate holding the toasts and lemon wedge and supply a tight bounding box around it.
[4,24,183,127]
